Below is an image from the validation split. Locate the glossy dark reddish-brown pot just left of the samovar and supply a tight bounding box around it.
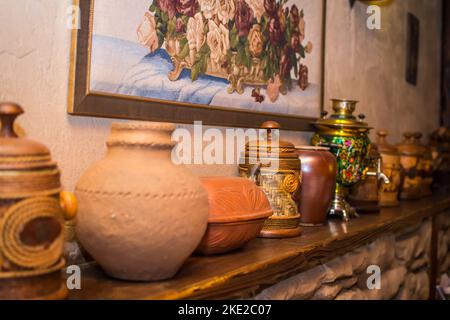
[296,146,337,226]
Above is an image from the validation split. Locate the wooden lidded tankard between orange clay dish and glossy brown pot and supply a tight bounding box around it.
[239,121,301,238]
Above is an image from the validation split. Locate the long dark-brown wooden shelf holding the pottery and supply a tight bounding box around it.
[70,192,450,300]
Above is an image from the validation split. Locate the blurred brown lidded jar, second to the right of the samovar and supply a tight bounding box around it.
[397,132,423,200]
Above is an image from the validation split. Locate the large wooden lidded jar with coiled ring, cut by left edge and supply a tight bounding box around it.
[0,103,76,299]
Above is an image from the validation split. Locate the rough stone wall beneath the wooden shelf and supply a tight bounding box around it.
[255,219,432,300]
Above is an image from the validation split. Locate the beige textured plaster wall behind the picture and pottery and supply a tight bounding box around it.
[0,0,442,189]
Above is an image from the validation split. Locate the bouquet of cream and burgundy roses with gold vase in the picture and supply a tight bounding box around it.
[138,0,313,102]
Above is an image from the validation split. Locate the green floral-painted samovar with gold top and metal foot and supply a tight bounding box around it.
[312,99,371,221]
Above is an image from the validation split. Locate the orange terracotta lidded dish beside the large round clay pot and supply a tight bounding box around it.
[197,177,273,255]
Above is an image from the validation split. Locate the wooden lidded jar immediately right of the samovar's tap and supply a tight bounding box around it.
[377,130,403,207]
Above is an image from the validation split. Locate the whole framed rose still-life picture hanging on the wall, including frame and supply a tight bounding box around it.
[69,0,326,131]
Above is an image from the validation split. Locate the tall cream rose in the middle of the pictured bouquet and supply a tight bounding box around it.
[206,20,230,69]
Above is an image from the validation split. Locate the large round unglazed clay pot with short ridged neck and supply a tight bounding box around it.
[76,122,208,281]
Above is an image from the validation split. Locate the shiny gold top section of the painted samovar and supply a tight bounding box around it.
[314,99,371,130]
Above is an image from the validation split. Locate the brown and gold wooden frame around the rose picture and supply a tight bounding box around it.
[68,0,327,131]
